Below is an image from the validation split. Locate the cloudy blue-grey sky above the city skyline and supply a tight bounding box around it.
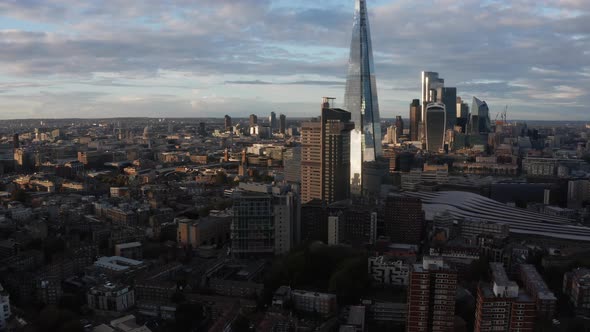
[0,0,590,121]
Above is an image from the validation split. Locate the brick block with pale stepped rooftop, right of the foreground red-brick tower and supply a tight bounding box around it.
[474,263,535,332]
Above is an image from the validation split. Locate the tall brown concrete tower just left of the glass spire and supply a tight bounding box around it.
[301,98,354,203]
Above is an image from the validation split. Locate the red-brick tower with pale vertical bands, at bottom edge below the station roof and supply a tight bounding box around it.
[406,256,457,332]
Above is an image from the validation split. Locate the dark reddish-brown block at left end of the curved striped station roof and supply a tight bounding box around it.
[382,194,424,244]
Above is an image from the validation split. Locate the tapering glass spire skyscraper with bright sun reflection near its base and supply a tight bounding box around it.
[344,0,381,195]
